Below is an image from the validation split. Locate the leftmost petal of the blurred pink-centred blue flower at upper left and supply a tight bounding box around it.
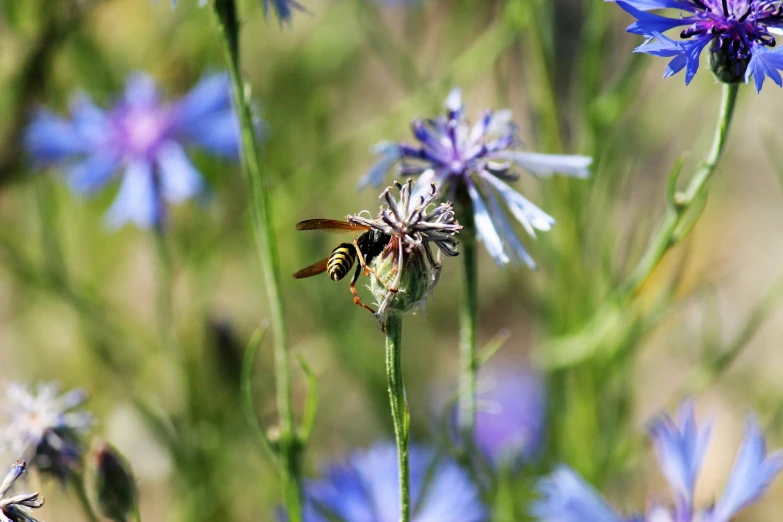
[24,110,88,163]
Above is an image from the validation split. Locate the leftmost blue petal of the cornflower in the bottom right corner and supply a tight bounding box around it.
[530,466,623,522]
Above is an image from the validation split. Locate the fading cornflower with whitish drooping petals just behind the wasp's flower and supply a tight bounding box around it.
[360,89,592,268]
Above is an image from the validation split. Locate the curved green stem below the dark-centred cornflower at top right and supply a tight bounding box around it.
[619,84,739,304]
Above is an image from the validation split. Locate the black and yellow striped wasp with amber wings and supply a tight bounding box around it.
[294,219,394,314]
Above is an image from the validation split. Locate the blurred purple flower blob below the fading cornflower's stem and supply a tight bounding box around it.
[475,365,546,467]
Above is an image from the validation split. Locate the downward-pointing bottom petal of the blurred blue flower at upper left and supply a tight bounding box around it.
[106,161,162,228]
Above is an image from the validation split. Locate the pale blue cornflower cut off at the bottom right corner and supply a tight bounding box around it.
[531,402,783,522]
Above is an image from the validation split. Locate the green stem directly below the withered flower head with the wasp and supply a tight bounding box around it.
[386,314,411,522]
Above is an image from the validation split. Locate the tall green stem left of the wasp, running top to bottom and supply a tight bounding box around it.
[214,0,302,522]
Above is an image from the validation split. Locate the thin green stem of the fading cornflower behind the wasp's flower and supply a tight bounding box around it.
[457,205,478,451]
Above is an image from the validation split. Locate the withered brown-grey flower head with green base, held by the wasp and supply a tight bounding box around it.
[348,179,462,319]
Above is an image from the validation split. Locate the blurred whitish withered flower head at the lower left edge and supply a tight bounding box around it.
[0,383,93,481]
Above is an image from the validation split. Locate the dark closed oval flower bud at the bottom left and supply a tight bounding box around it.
[91,442,138,522]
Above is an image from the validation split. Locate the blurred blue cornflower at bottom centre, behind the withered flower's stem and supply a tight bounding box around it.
[304,443,489,522]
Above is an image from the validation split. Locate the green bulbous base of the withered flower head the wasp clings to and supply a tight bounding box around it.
[370,239,434,315]
